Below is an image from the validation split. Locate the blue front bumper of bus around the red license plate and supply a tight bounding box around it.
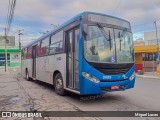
[80,78,135,94]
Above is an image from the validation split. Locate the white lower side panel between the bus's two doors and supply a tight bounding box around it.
[36,53,66,84]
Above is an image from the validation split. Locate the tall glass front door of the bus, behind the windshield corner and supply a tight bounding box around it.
[66,27,79,90]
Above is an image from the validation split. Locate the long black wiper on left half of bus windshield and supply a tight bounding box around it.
[97,23,112,50]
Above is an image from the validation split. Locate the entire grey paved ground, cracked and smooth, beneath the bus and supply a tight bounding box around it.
[0,74,160,120]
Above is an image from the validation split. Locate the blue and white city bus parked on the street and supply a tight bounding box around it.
[22,12,135,95]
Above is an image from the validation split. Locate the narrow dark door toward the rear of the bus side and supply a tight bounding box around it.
[32,45,37,78]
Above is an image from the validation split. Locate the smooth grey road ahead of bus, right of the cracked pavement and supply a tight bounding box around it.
[66,77,160,111]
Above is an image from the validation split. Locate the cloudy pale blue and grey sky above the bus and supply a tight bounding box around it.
[0,0,160,45]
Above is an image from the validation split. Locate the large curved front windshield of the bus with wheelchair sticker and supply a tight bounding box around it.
[84,25,134,63]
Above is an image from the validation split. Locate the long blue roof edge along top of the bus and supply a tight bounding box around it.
[22,11,128,49]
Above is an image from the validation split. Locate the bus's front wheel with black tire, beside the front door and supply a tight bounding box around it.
[54,73,65,96]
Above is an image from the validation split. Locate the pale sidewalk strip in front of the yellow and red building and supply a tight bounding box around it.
[136,72,160,79]
